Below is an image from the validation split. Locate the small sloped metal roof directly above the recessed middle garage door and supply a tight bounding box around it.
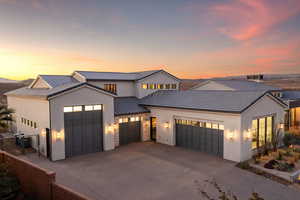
[114,97,150,115]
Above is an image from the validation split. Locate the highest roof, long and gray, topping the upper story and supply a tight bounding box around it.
[74,70,179,81]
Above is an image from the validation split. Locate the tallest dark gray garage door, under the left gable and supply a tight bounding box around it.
[64,106,103,157]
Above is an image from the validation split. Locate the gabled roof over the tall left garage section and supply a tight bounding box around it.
[5,82,115,99]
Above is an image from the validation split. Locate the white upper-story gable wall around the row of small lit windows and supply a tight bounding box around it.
[136,72,180,98]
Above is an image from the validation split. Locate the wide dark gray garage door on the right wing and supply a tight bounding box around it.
[176,120,224,157]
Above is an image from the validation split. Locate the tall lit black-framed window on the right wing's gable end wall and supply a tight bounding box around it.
[251,116,274,149]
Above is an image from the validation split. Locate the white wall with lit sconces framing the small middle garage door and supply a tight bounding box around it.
[114,113,150,147]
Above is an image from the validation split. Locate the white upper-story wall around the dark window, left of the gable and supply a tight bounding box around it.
[88,81,135,97]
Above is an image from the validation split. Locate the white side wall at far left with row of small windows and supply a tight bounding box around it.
[7,96,50,156]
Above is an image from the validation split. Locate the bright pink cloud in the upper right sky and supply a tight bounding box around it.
[210,0,300,40]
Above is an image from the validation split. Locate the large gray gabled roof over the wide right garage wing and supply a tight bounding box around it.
[140,90,286,113]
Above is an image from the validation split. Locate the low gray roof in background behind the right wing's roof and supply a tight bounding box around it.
[192,79,280,91]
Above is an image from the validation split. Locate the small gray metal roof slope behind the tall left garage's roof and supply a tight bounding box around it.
[40,75,79,88]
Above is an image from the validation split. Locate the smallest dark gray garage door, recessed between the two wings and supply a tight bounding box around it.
[119,119,141,145]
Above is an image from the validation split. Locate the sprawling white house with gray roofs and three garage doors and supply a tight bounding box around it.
[6,70,287,162]
